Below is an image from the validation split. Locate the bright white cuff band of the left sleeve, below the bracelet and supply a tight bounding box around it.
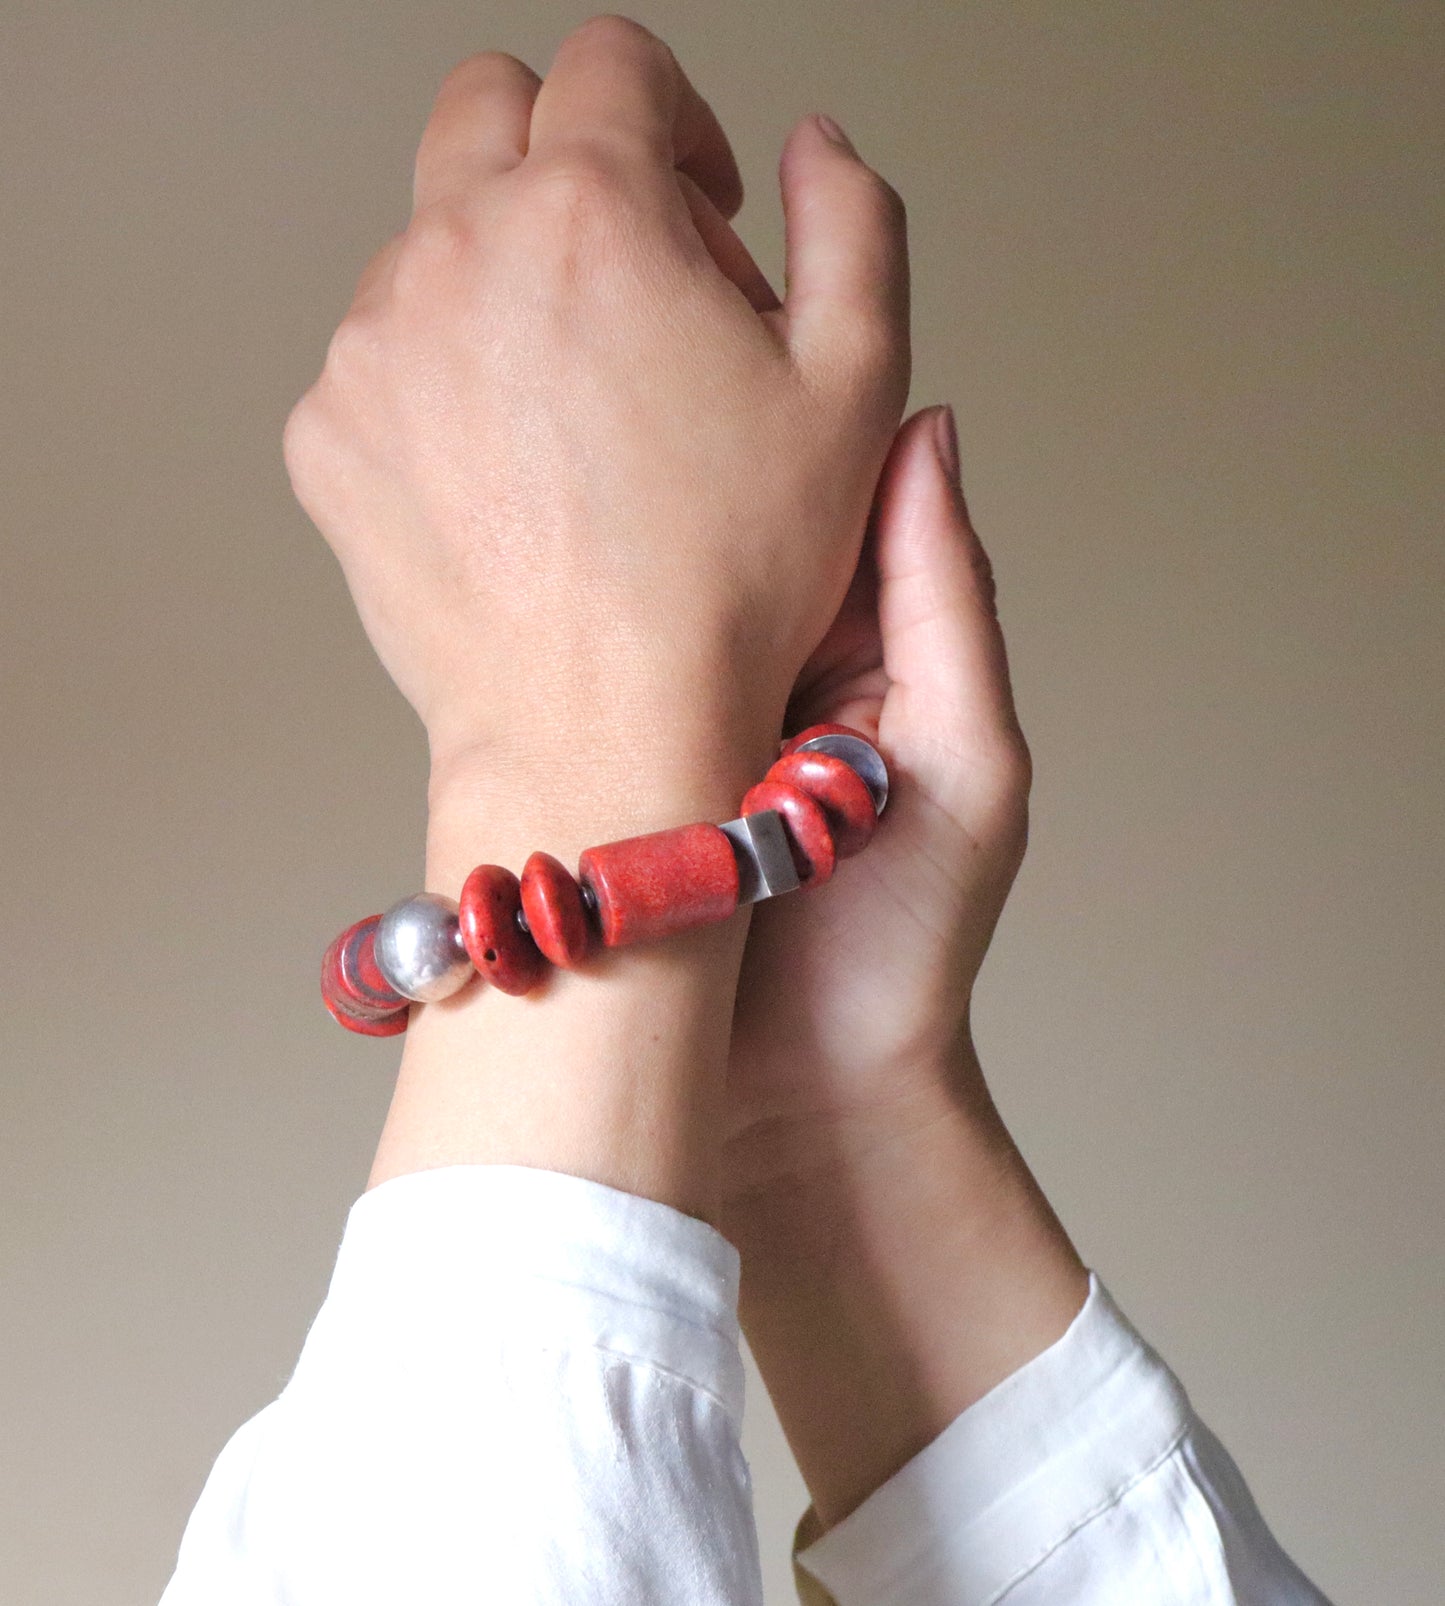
[287,1164,743,1426]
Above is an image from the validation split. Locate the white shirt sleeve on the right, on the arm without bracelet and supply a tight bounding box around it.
[793,1278,1328,1606]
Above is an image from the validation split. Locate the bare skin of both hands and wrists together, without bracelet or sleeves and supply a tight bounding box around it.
[286,6,1084,1541]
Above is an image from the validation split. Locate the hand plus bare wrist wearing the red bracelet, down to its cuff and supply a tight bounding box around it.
[308,18,907,1217]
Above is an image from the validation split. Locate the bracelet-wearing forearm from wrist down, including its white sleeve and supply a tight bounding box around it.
[167,719,769,1606]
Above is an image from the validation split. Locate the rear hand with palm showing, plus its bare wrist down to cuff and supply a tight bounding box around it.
[718,398,1087,1516]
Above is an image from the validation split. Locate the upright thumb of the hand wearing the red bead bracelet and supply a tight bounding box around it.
[779,117,909,391]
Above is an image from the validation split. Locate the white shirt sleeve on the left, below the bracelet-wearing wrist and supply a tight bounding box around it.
[162,1166,763,1606]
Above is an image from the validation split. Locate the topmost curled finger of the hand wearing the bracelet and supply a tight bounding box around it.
[530,16,742,218]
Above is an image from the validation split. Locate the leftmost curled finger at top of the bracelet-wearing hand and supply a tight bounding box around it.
[411,50,541,209]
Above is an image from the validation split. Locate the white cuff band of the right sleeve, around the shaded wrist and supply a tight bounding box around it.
[793,1275,1193,1606]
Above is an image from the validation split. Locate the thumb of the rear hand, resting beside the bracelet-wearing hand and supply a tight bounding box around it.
[875,408,1024,779]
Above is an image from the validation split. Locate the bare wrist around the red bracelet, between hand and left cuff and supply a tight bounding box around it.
[371,722,780,1219]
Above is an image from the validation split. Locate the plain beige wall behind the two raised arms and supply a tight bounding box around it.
[0,0,1445,1606]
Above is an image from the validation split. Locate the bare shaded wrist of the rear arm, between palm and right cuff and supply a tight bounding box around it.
[724,1042,1089,1527]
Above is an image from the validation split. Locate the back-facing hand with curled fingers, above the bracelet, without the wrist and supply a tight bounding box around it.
[286,18,907,815]
